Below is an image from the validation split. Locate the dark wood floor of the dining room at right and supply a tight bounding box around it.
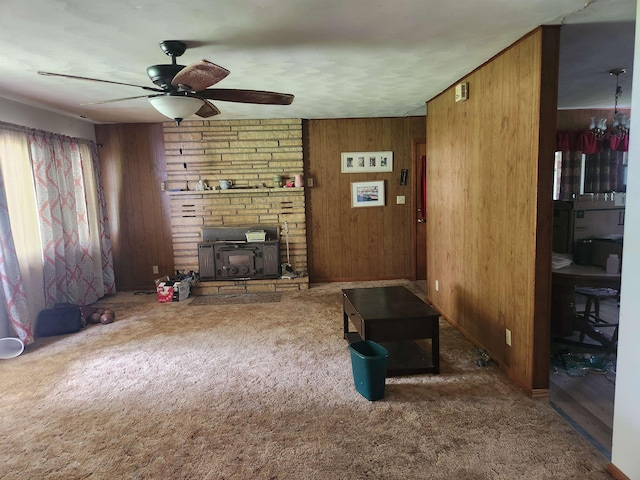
[549,295,618,459]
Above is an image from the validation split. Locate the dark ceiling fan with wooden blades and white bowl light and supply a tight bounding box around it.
[38,40,293,125]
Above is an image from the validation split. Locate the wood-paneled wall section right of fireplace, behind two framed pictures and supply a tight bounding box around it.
[305,117,425,282]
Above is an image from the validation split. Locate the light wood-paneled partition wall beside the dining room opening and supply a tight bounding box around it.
[427,27,559,395]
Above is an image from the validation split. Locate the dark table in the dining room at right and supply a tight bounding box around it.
[551,264,620,350]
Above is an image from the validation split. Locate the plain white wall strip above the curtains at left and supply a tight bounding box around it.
[0,97,96,141]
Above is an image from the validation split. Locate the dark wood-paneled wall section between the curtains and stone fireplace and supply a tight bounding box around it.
[96,124,174,290]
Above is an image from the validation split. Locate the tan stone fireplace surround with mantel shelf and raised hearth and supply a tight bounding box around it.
[164,119,309,295]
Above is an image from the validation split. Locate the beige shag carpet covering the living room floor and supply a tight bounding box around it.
[0,282,609,480]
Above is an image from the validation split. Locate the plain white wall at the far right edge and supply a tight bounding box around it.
[611,2,640,479]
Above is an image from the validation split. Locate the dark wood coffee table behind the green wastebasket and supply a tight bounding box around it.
[342,286,440,377]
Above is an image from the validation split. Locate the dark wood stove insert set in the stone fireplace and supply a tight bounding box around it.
[198,228,280,280]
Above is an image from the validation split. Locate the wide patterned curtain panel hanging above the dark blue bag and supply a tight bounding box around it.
[29,131,102,307]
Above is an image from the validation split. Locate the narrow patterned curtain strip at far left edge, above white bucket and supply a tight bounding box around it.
[0,169,34,345]
